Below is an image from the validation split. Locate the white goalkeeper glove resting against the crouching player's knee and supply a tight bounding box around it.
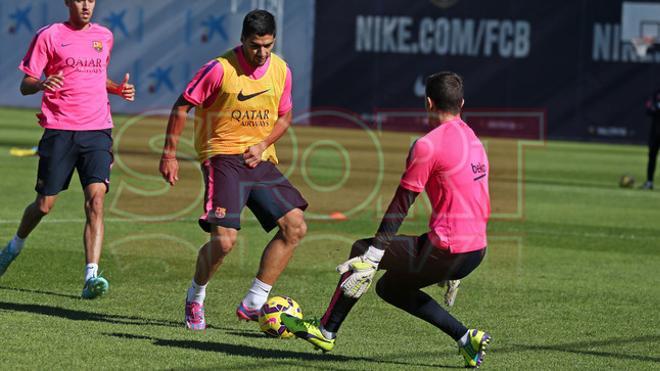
[337,246,384,299]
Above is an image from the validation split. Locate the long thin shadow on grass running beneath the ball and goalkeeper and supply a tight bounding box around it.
[104,333,462,369]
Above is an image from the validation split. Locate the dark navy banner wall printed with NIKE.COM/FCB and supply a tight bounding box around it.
[312,0,660,142]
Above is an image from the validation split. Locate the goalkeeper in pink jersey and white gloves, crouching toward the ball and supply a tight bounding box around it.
[282,72,490,367]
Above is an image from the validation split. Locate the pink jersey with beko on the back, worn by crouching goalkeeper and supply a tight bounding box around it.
[401,118,490,254]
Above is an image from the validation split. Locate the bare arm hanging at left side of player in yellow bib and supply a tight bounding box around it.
[159,95,194,185]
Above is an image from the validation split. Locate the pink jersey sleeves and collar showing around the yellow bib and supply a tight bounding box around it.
[183,46,293,116]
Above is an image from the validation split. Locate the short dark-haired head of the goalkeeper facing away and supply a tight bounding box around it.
[426,71,463,114]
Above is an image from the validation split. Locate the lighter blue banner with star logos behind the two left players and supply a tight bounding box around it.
[0,0,315,113]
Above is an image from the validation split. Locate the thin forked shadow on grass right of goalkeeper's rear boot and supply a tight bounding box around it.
[493,335,660,363]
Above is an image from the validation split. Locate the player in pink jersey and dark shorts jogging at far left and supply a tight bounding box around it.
[0,0,135,299]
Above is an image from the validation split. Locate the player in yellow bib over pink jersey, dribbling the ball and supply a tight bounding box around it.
[159,9,307,330]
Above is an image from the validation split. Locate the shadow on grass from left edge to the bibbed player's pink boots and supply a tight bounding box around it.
[0,299,253,336]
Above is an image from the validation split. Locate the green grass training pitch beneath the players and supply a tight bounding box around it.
[0,109,660,370]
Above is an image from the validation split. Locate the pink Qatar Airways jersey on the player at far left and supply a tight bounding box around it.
[18,23,113,130]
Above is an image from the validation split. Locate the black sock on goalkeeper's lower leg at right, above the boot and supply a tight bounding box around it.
[376,282,468,341]
